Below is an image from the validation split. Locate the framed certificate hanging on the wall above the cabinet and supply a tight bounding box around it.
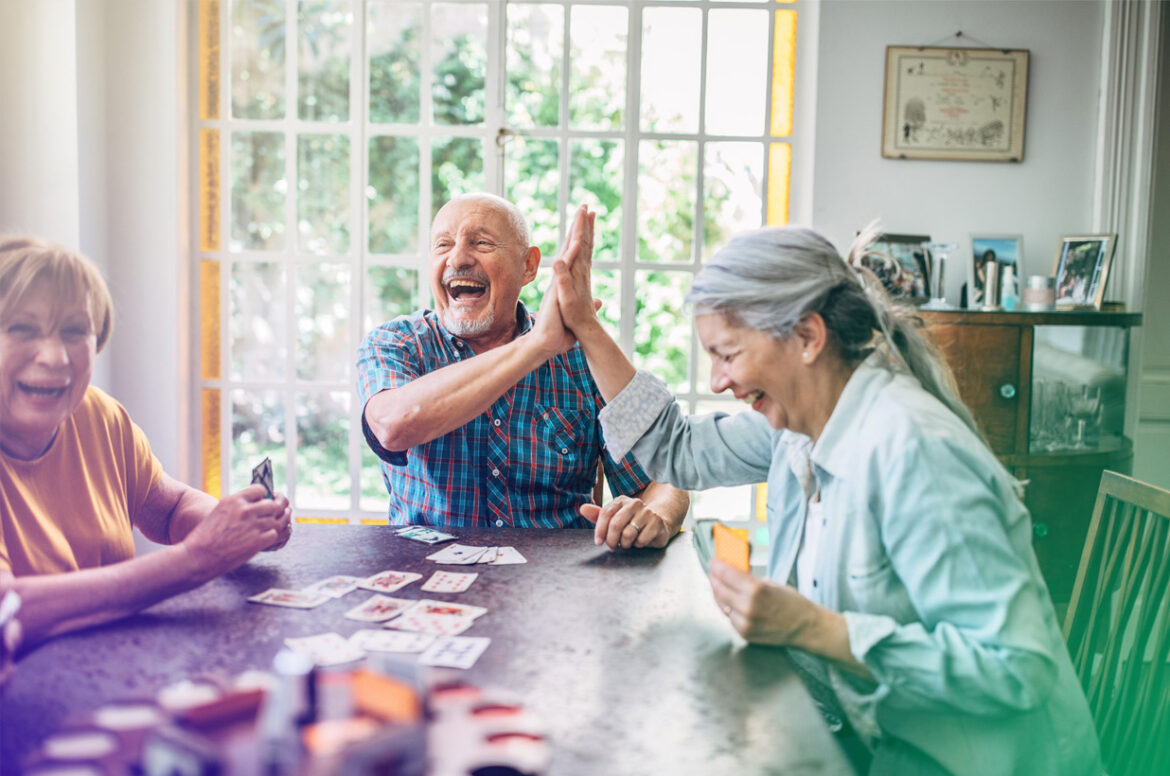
[881,46,1028,162]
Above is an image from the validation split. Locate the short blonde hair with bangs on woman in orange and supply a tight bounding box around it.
[0,234,113,352]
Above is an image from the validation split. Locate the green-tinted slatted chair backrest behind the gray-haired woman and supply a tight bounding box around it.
[1065,472,1170,776]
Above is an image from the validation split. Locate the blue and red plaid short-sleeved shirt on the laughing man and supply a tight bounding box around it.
[358,303,651,528]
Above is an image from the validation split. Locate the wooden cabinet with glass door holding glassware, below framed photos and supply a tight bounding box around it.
[920,310,1142,604]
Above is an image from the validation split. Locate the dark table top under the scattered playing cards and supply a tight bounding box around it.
[0,524,852,775]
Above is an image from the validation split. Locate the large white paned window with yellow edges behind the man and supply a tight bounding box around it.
[192,0,799,538]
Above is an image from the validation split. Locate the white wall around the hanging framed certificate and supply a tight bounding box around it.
[812,0,1108,303]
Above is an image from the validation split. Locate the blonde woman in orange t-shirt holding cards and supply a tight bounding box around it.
[0,235,290,646]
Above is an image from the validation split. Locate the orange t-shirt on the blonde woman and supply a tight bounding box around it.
[0,385,163,577]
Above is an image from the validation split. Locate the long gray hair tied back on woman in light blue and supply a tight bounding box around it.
[687,224,986,444]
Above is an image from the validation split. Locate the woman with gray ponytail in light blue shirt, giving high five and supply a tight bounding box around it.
[542,209,1101,776]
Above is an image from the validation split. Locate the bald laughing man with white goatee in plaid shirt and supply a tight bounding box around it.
[358,193,689,549]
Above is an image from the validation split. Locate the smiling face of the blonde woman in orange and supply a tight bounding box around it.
[0,280,97,459]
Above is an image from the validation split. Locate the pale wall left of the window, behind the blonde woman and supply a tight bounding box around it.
[0,0,190,476]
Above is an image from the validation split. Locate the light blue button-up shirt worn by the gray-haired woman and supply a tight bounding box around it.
[601,353,1102,776]
